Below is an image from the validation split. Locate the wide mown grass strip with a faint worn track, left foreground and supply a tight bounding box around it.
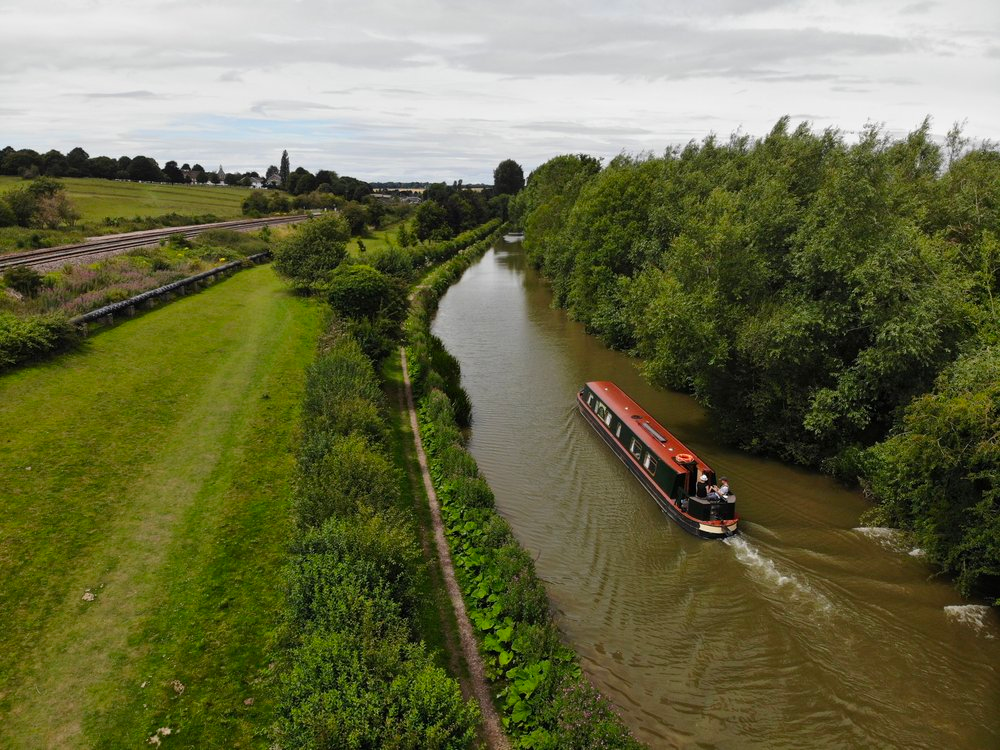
[0,267,323,748]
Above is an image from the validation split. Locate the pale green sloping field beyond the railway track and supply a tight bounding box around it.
[0,176,250,224]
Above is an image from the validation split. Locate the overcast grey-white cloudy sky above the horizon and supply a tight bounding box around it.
[0,0,1000,183]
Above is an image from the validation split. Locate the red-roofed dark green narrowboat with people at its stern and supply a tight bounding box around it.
[576,380,739,539]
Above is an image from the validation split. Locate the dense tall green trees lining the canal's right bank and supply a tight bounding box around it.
[511,118,1000,595]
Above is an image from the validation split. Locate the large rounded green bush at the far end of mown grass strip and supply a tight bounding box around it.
[274,214,351,287]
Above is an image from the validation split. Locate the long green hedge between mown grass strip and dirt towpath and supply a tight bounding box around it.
[276,328,479,750]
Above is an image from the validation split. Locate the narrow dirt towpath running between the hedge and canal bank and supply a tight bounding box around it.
[399,348,510,750]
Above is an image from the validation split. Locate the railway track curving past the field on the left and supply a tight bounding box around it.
[0,214,308,271]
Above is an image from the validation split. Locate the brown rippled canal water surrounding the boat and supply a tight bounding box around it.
[434,243,1000,749]
